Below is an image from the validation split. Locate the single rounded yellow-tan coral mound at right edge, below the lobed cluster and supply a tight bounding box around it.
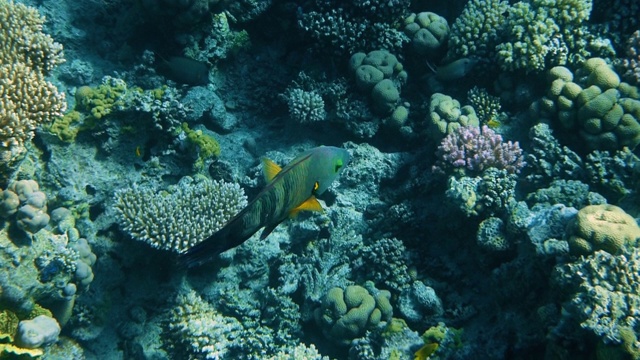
[567,204,640,255]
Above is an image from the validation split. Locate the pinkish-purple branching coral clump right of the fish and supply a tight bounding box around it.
[434,125,525,174]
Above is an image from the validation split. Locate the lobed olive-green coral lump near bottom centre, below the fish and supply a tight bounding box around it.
[314,285,393,345]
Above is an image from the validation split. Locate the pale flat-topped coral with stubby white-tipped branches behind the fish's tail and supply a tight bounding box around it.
[115,177,247,252]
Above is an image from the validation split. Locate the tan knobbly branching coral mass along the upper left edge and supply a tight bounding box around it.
[0,0,66,172]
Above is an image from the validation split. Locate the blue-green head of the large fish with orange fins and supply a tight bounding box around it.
[310,146,351,195]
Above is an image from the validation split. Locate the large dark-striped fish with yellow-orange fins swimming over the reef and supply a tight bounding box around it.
[178,146,350,268]
